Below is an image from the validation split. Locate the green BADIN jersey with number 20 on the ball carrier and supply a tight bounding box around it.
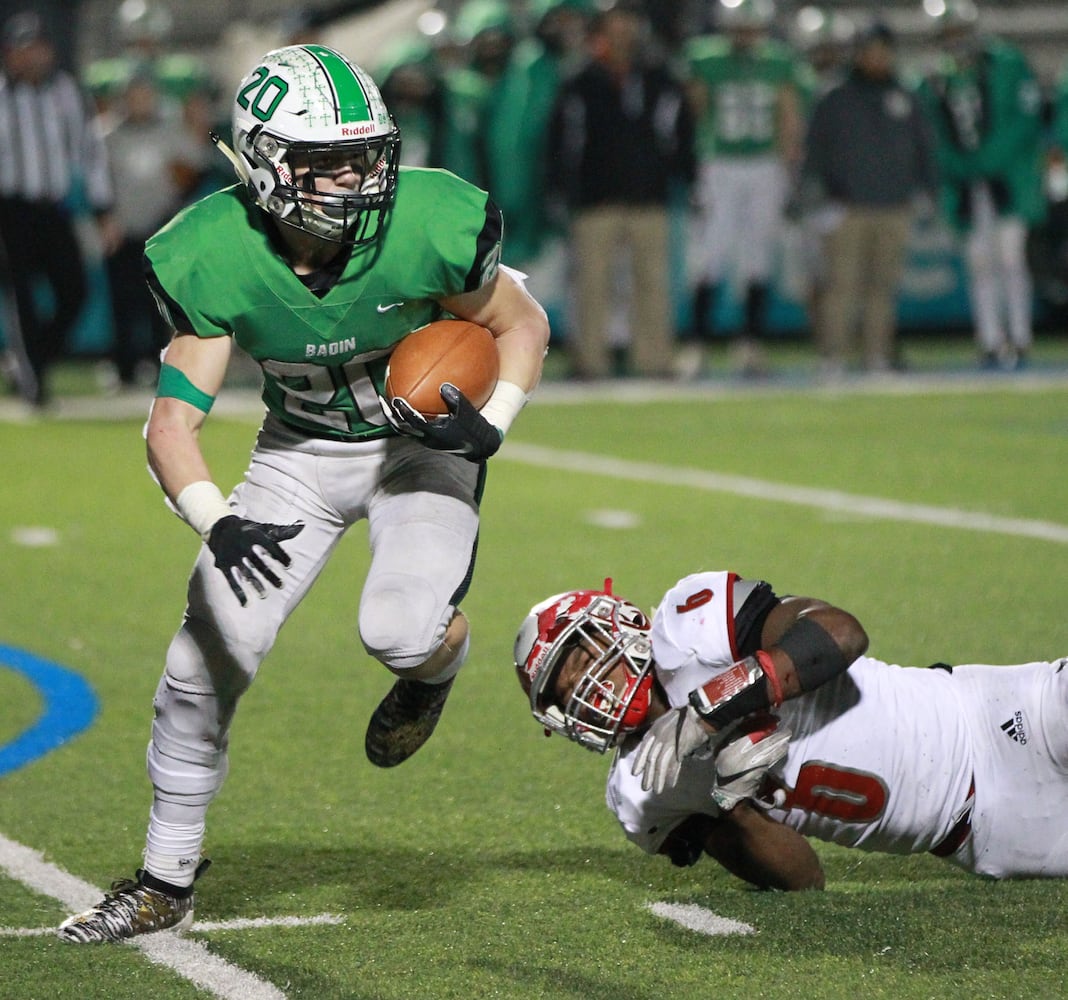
[145,167,501,440]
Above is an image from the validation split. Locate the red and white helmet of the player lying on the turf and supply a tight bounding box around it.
[515,580,653,753]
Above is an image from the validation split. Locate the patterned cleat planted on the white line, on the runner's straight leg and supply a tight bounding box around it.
[56,859,211,944]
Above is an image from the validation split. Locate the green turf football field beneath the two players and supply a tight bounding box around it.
[0,348,1068,1000]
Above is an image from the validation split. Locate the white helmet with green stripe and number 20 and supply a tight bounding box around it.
[232,45,401,245]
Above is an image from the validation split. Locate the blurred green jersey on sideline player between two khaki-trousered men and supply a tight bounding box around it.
[685,35,799,160]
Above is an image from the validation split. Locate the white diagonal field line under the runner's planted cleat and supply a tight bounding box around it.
[0,833,296,1000]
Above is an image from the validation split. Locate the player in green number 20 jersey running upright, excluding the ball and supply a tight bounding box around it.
[60,45,549,942]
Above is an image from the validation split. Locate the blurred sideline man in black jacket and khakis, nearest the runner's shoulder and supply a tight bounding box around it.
[548,4,695,379]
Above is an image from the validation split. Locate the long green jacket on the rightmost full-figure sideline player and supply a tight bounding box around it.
[920,40,1046,229]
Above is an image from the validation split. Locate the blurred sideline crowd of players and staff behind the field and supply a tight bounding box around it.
[0,0,1068,405]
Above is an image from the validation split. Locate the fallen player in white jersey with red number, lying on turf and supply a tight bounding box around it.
[516,572,1068,889]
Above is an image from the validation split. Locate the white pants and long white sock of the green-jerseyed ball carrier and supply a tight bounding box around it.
[145,417,485,885]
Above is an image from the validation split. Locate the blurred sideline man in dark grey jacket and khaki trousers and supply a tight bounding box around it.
[802,24,937,374]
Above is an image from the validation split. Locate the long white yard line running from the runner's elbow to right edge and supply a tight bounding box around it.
[497,440,1068,544]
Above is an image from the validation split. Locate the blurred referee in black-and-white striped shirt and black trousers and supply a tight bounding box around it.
[0,12,119,406]
